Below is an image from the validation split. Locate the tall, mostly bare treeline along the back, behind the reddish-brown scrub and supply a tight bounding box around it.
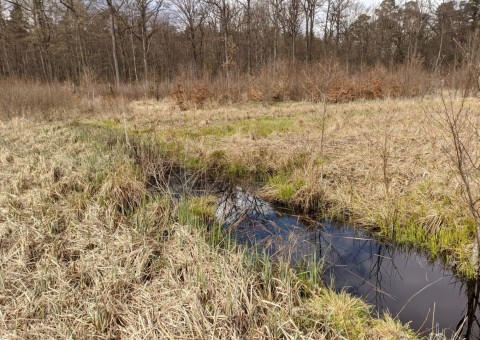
[0,0,480,84]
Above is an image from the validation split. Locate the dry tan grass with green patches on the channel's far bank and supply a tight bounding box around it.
[75,96,480,276]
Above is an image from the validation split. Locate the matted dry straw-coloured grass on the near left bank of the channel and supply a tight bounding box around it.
[0,117,411,339]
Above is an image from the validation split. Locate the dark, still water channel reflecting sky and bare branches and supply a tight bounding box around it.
[217,191,480,339]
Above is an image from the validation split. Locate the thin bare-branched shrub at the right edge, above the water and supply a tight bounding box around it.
[427,32,480,275]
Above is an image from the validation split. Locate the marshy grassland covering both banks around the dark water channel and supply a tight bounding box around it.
[0,87,472,339]
